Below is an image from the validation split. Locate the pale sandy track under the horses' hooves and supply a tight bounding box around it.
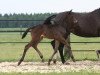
[0,61,100,73]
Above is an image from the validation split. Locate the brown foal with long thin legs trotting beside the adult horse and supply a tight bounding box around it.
[18,12,78,65]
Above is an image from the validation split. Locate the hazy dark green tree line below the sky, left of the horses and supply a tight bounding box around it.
[0,13,54,28]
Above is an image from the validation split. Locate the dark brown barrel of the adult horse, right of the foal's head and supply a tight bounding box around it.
[73,9,100,37]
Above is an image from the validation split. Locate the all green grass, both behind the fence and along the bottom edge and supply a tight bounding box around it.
[0,30,100,75]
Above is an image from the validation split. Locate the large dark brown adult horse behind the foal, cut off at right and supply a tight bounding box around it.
[45,8,100,62]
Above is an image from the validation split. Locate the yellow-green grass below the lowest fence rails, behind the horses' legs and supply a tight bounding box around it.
[0,44,97,62]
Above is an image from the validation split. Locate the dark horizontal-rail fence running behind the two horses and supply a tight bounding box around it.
[0,20,100,51]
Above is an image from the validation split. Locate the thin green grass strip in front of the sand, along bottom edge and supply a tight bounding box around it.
[0,72,100,75]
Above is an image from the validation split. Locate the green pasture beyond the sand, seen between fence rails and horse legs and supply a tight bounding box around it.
[0,33,100,62]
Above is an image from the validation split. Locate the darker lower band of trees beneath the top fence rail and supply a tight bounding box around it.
[0,20,44,28]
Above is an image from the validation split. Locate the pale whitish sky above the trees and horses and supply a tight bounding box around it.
[0,0,100,14]
